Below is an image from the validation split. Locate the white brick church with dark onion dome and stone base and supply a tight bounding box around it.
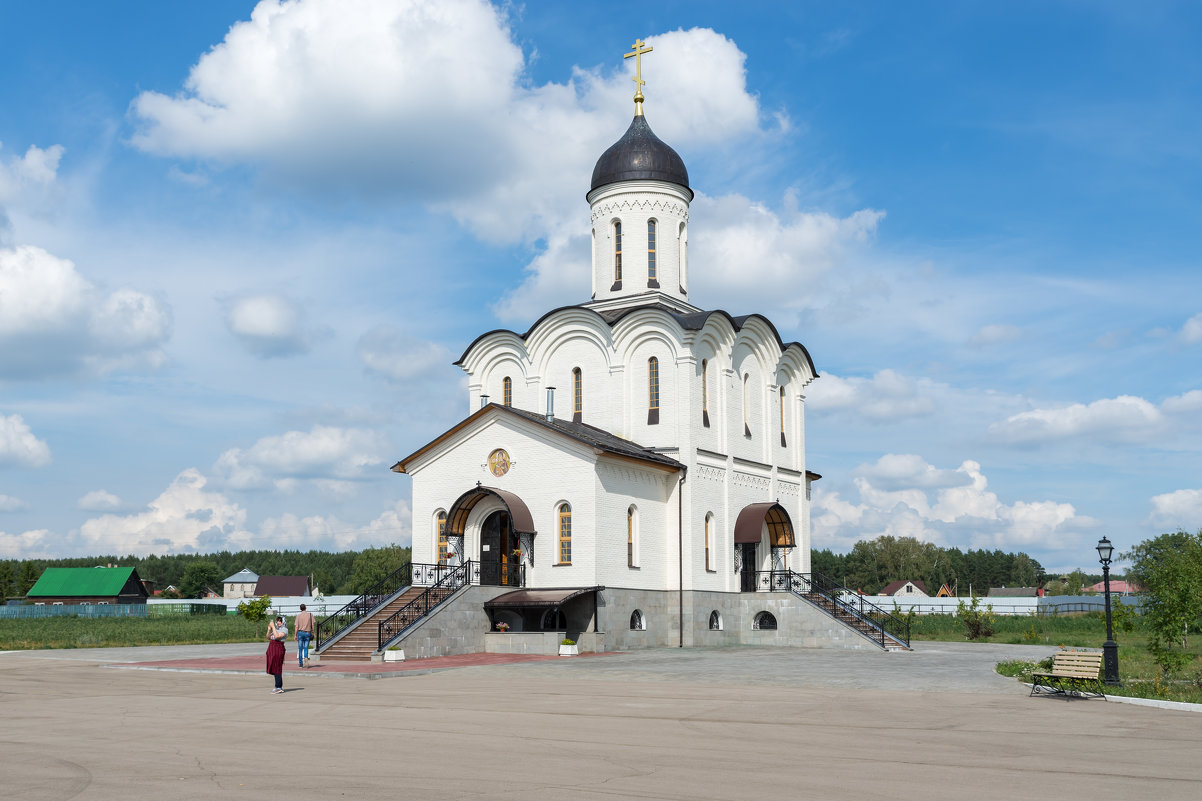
[319,42,903,654]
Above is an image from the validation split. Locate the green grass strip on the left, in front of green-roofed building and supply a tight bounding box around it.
[0,615,266,651]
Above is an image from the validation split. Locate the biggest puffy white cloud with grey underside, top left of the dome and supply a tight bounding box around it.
[132,0,523,192]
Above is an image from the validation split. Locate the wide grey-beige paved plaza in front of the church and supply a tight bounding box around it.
[0,642,1202,801]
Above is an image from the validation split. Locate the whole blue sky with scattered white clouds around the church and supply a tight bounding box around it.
[0,0,1202,570]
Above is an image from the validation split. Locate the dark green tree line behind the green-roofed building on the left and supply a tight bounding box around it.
[0,545,410,598]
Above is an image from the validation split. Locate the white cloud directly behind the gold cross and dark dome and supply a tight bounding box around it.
[435,28,778,245]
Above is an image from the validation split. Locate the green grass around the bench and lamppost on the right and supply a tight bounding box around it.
[910,612,1202,704]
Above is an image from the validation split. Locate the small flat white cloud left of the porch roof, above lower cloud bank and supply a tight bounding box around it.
[213,426,387,494]
